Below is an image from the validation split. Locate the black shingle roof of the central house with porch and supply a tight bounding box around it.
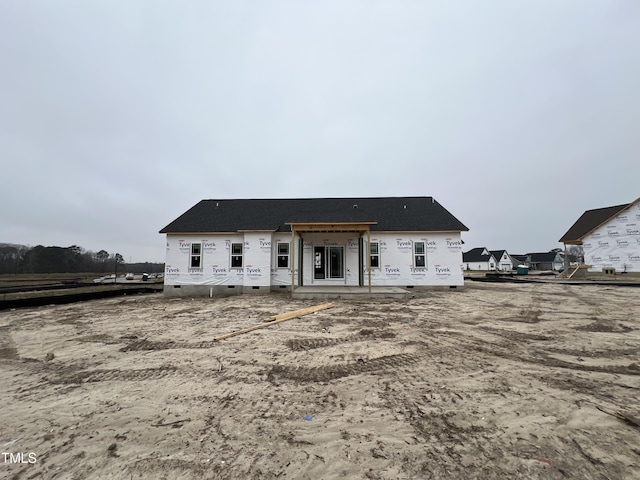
[160,197,469,233]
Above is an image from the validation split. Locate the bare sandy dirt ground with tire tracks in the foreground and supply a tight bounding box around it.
[0,282,640,480]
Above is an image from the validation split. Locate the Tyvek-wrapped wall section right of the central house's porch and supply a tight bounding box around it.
[363,232,464,286]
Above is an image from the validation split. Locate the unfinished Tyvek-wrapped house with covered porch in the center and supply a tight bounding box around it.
[160,197,468,295]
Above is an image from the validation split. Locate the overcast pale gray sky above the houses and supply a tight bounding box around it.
[0,0,640,262]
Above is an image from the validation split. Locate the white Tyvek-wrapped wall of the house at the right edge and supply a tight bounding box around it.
[582,202,640,272]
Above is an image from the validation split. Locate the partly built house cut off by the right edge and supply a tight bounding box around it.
[560,198,640,272]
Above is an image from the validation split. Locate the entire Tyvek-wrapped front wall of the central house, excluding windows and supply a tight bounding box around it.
[164,232,464,296]
